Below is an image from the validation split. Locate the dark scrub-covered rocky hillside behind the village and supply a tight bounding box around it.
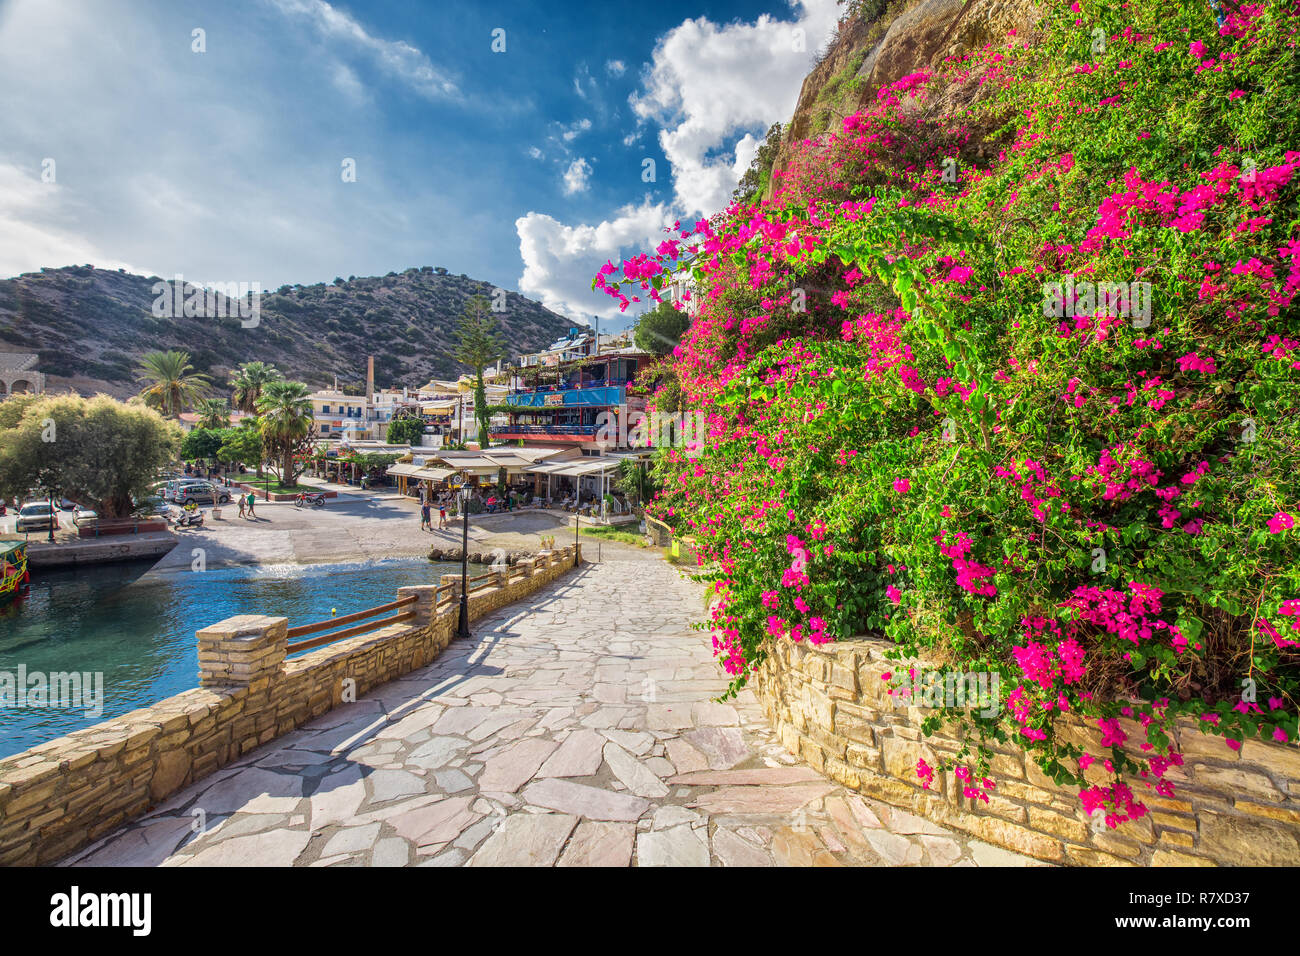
[0,265,572,397]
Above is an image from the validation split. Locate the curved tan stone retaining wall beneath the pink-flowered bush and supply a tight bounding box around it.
[750,639,1300,866]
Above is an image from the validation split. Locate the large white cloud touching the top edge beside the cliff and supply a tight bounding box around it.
[631,0,839,215]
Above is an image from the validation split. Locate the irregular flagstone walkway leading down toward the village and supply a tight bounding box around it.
[65,554,1031,866]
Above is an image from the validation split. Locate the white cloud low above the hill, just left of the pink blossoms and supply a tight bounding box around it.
[515,198,675,321]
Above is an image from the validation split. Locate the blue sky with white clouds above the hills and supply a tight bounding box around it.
[0,0,839,326]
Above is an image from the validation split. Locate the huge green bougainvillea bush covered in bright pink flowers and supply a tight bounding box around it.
[595,0,1300,826]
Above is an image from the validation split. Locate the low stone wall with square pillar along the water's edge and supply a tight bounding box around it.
[0,546,582,865]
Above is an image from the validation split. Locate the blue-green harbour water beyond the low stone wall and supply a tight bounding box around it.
[0,558,460,757]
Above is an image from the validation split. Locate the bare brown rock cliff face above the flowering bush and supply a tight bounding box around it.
[776,0,1041,180]
